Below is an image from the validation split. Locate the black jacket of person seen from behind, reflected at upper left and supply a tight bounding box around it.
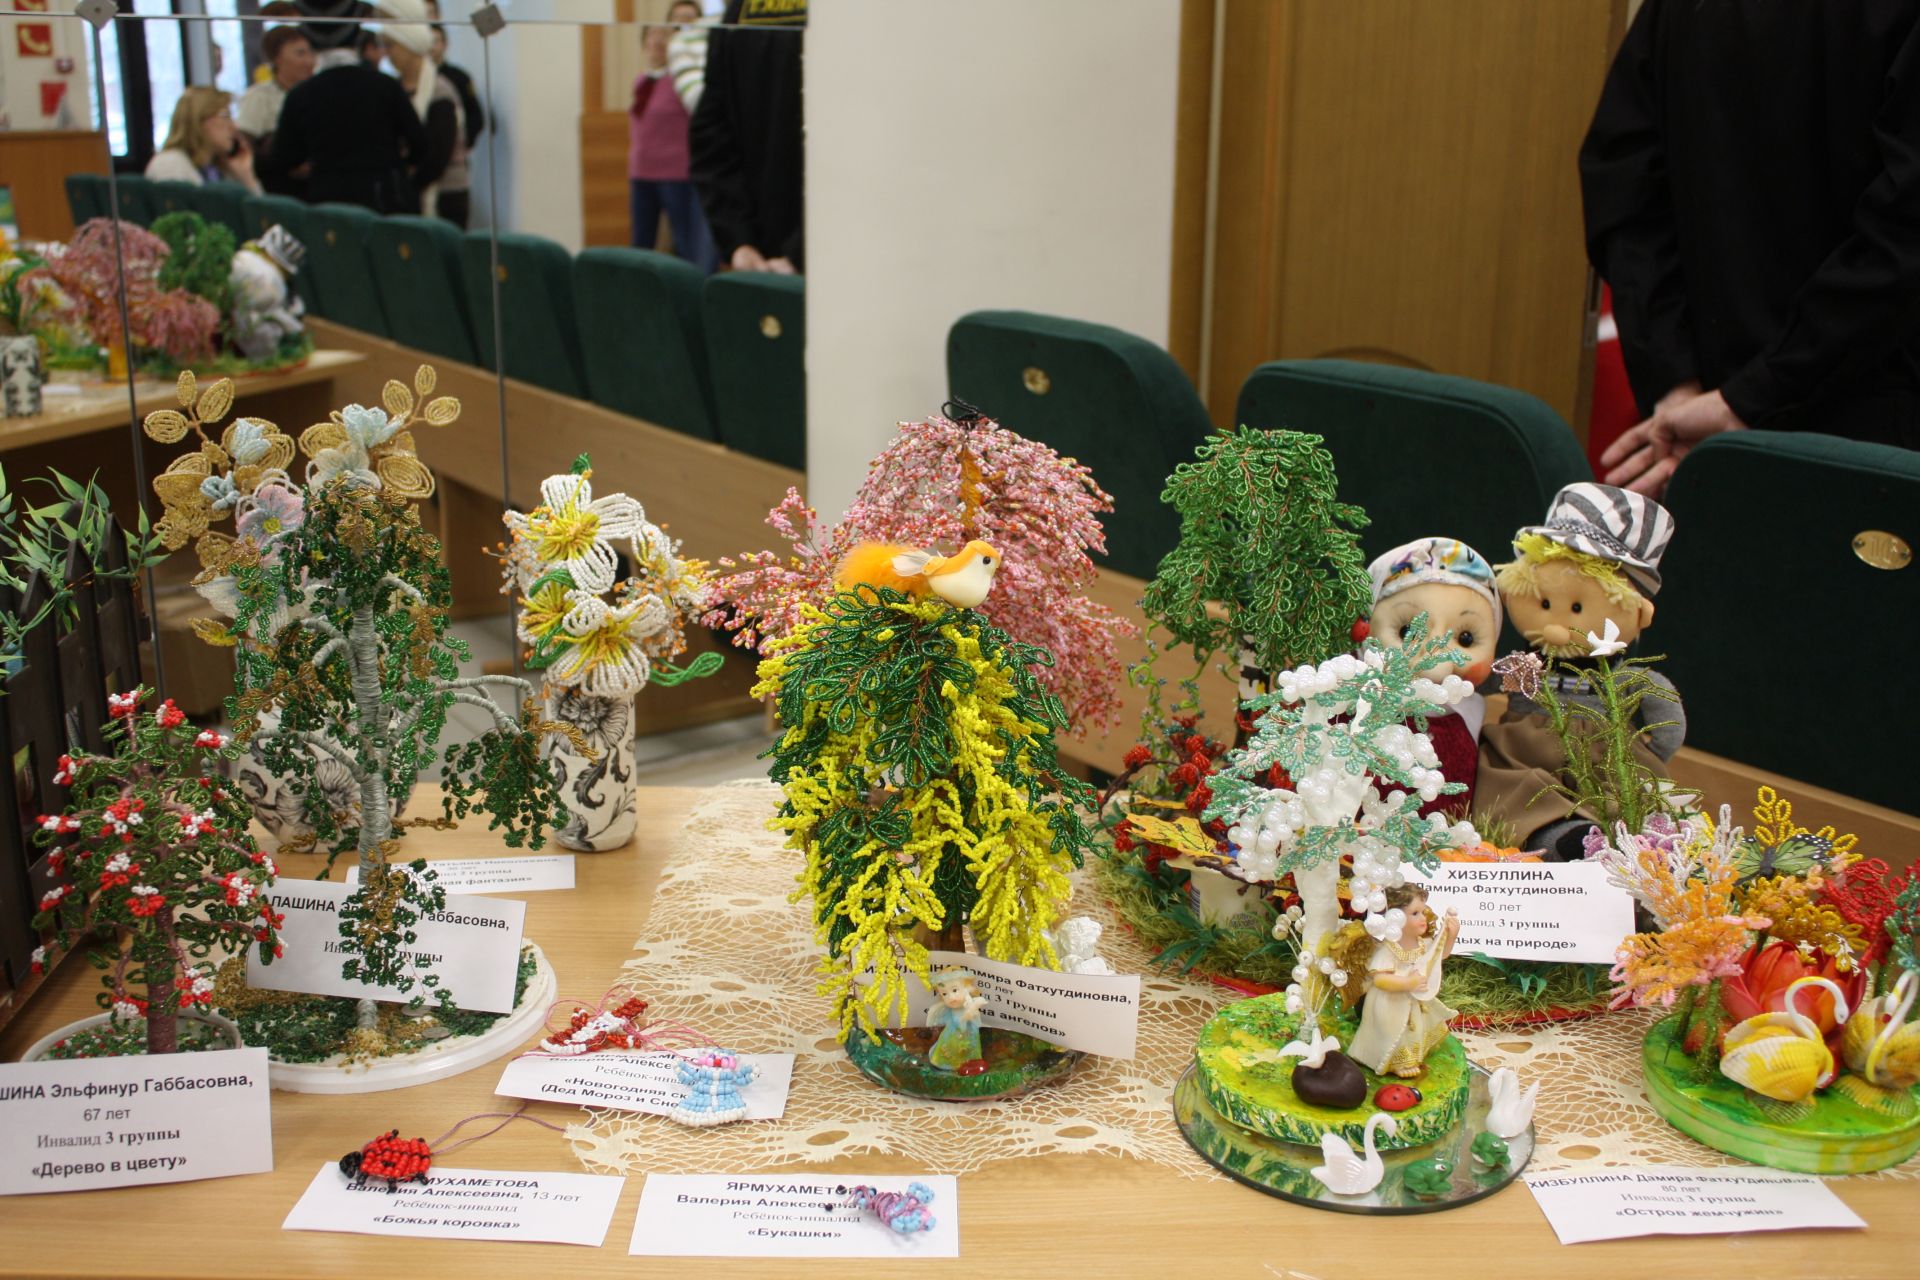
[259,46,428,213]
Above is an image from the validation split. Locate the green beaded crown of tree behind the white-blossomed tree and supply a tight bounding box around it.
[1140,426,1373,717]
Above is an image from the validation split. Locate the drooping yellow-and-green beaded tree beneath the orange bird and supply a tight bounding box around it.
[755,587,1092,1038]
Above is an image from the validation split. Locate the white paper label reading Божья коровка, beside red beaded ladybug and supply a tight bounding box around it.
[280,1163,626,1247]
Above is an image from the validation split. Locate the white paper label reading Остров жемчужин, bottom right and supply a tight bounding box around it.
[1526,1165,1866,1244]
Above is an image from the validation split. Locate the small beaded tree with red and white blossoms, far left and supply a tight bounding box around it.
[35,689,280,1054]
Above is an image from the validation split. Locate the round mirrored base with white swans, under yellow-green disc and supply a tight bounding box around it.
[1173,1063,1534,1215]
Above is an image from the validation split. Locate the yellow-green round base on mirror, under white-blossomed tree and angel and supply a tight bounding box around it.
[1194,994,1473,1151]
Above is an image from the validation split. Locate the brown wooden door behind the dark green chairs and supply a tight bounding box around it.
[1173,0,1626,434]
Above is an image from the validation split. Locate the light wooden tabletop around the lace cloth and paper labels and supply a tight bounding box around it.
[0,789,1920,1280]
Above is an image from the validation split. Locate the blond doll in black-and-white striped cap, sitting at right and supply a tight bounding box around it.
[1478,484,1686,862]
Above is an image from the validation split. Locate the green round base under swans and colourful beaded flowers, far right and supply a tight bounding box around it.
[1640,1017,1920,1174]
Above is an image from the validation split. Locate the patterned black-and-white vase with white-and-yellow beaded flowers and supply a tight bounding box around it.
[501,453,720,852]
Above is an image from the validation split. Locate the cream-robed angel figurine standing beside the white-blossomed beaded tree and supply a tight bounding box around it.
[1346,885,1459,1079]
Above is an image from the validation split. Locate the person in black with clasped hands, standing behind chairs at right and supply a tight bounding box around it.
[1580,0,1920,495]
